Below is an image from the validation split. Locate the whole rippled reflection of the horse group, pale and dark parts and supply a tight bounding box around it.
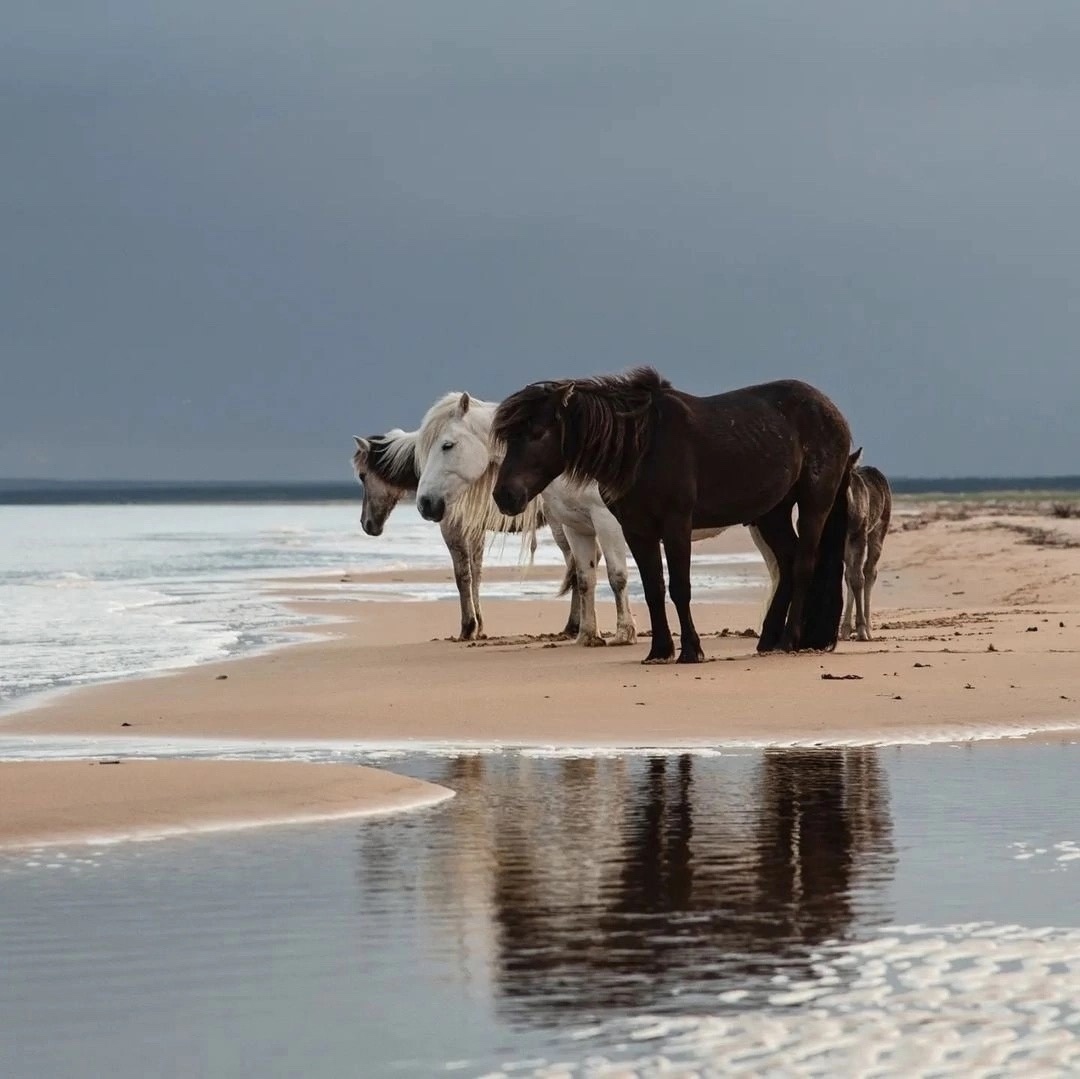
[354,750,893,1025]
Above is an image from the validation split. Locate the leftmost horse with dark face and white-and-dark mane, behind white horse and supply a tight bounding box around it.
[352,428,548,640]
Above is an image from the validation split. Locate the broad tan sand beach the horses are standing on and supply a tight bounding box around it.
[0,508,1080,846]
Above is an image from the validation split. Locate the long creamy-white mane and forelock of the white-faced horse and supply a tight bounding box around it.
[415,391,540,561]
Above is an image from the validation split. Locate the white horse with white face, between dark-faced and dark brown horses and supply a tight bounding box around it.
[416,393,637,646]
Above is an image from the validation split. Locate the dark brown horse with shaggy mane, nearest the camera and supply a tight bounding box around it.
[491,367,851,663]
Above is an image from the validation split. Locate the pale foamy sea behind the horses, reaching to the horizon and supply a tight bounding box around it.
[0,497,760,710]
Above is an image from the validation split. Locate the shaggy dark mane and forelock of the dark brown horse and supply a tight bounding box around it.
[491,367,671,497]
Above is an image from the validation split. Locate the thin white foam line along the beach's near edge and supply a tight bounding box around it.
[0,721,1080,764]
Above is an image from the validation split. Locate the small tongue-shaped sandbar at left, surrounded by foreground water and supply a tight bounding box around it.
[0,760,450,849]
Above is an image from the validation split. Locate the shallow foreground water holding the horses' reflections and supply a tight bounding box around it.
[0,743,1080,1079]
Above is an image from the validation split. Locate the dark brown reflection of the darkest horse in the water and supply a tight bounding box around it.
[494,751,890,1022]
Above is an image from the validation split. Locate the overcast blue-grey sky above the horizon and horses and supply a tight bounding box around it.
[0,0,1080,478]
